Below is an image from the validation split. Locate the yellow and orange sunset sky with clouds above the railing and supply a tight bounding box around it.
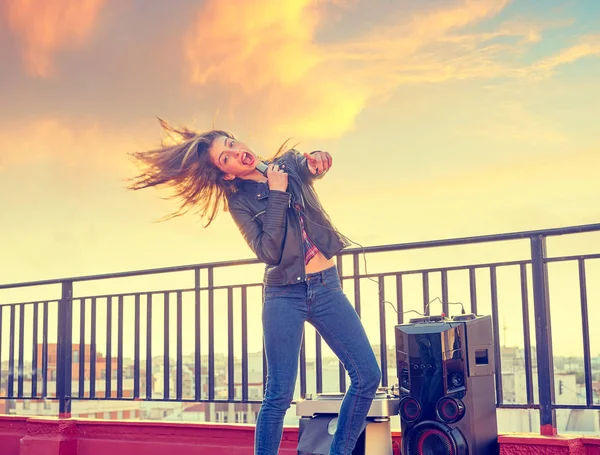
[0,0,600,364]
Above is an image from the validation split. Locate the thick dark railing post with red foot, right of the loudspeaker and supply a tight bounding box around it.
[530,235,556,436]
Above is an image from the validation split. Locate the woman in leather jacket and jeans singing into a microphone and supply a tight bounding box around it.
[130,121,381,455]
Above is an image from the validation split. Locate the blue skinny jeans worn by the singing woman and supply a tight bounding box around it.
[254,266,381,455]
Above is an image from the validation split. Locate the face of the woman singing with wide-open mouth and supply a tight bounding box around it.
[208,136,262,180]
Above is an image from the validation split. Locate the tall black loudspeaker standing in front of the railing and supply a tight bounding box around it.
[395,314,499,455]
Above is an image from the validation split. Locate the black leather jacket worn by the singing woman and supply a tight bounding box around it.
[228,150,348,286]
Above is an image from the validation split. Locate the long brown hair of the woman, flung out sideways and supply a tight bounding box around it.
[127,119,288,227]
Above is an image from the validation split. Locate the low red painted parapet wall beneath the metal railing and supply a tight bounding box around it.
[0,416,600,455]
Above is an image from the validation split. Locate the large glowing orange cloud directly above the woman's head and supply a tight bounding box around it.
[185,0,352,139]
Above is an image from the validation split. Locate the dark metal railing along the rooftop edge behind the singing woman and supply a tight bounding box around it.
[0,224,600,434]
